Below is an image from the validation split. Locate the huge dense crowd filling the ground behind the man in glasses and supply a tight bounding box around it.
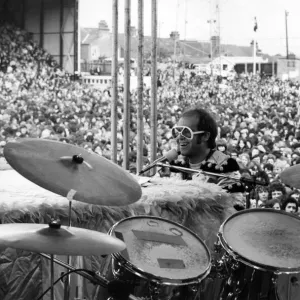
[0,23,300,210]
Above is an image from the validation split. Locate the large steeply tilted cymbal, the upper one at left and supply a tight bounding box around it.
[4,138,142,206]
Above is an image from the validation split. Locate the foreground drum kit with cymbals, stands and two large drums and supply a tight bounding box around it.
[0,138,300,300]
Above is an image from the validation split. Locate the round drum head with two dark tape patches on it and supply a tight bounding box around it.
[110,216,210,283]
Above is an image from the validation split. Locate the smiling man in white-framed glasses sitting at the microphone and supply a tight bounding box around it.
[172,108,244,193]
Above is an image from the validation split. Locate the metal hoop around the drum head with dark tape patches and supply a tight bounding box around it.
[108,215,211,286]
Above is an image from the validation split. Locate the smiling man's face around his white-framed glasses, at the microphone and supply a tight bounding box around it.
[178,117,203,156]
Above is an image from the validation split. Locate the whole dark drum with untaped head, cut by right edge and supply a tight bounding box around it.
[218,209,300,299]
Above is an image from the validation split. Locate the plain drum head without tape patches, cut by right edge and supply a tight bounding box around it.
[219,209,300,272]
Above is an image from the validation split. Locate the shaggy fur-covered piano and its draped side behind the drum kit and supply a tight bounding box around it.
[0,162,299,300]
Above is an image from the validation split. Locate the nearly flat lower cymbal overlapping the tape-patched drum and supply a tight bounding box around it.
[0,223,126,256]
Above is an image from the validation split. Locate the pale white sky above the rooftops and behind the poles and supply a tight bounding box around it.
[79,0,300,56]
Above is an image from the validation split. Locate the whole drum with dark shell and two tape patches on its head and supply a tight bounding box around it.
[97,216,211,300]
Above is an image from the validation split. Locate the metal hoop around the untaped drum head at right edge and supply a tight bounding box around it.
[218,208,300,274]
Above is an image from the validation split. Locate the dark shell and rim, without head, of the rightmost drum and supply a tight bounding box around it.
[218,209,299,300]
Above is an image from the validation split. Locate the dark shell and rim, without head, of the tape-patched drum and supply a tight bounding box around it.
[96,216,211,300]
